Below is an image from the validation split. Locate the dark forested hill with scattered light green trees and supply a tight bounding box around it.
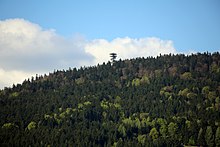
[0,53,220,147]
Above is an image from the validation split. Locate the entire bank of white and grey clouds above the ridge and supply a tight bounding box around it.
[0,19,176,89]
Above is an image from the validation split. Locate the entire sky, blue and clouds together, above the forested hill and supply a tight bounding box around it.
[0,0,220,89]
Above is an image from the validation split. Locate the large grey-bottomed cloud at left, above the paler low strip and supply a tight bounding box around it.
[0,19,92,71]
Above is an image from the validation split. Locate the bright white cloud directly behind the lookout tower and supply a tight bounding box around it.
[85,37,176,64]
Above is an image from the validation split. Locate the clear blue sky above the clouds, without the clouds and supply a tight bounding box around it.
[0,0,220,52]
